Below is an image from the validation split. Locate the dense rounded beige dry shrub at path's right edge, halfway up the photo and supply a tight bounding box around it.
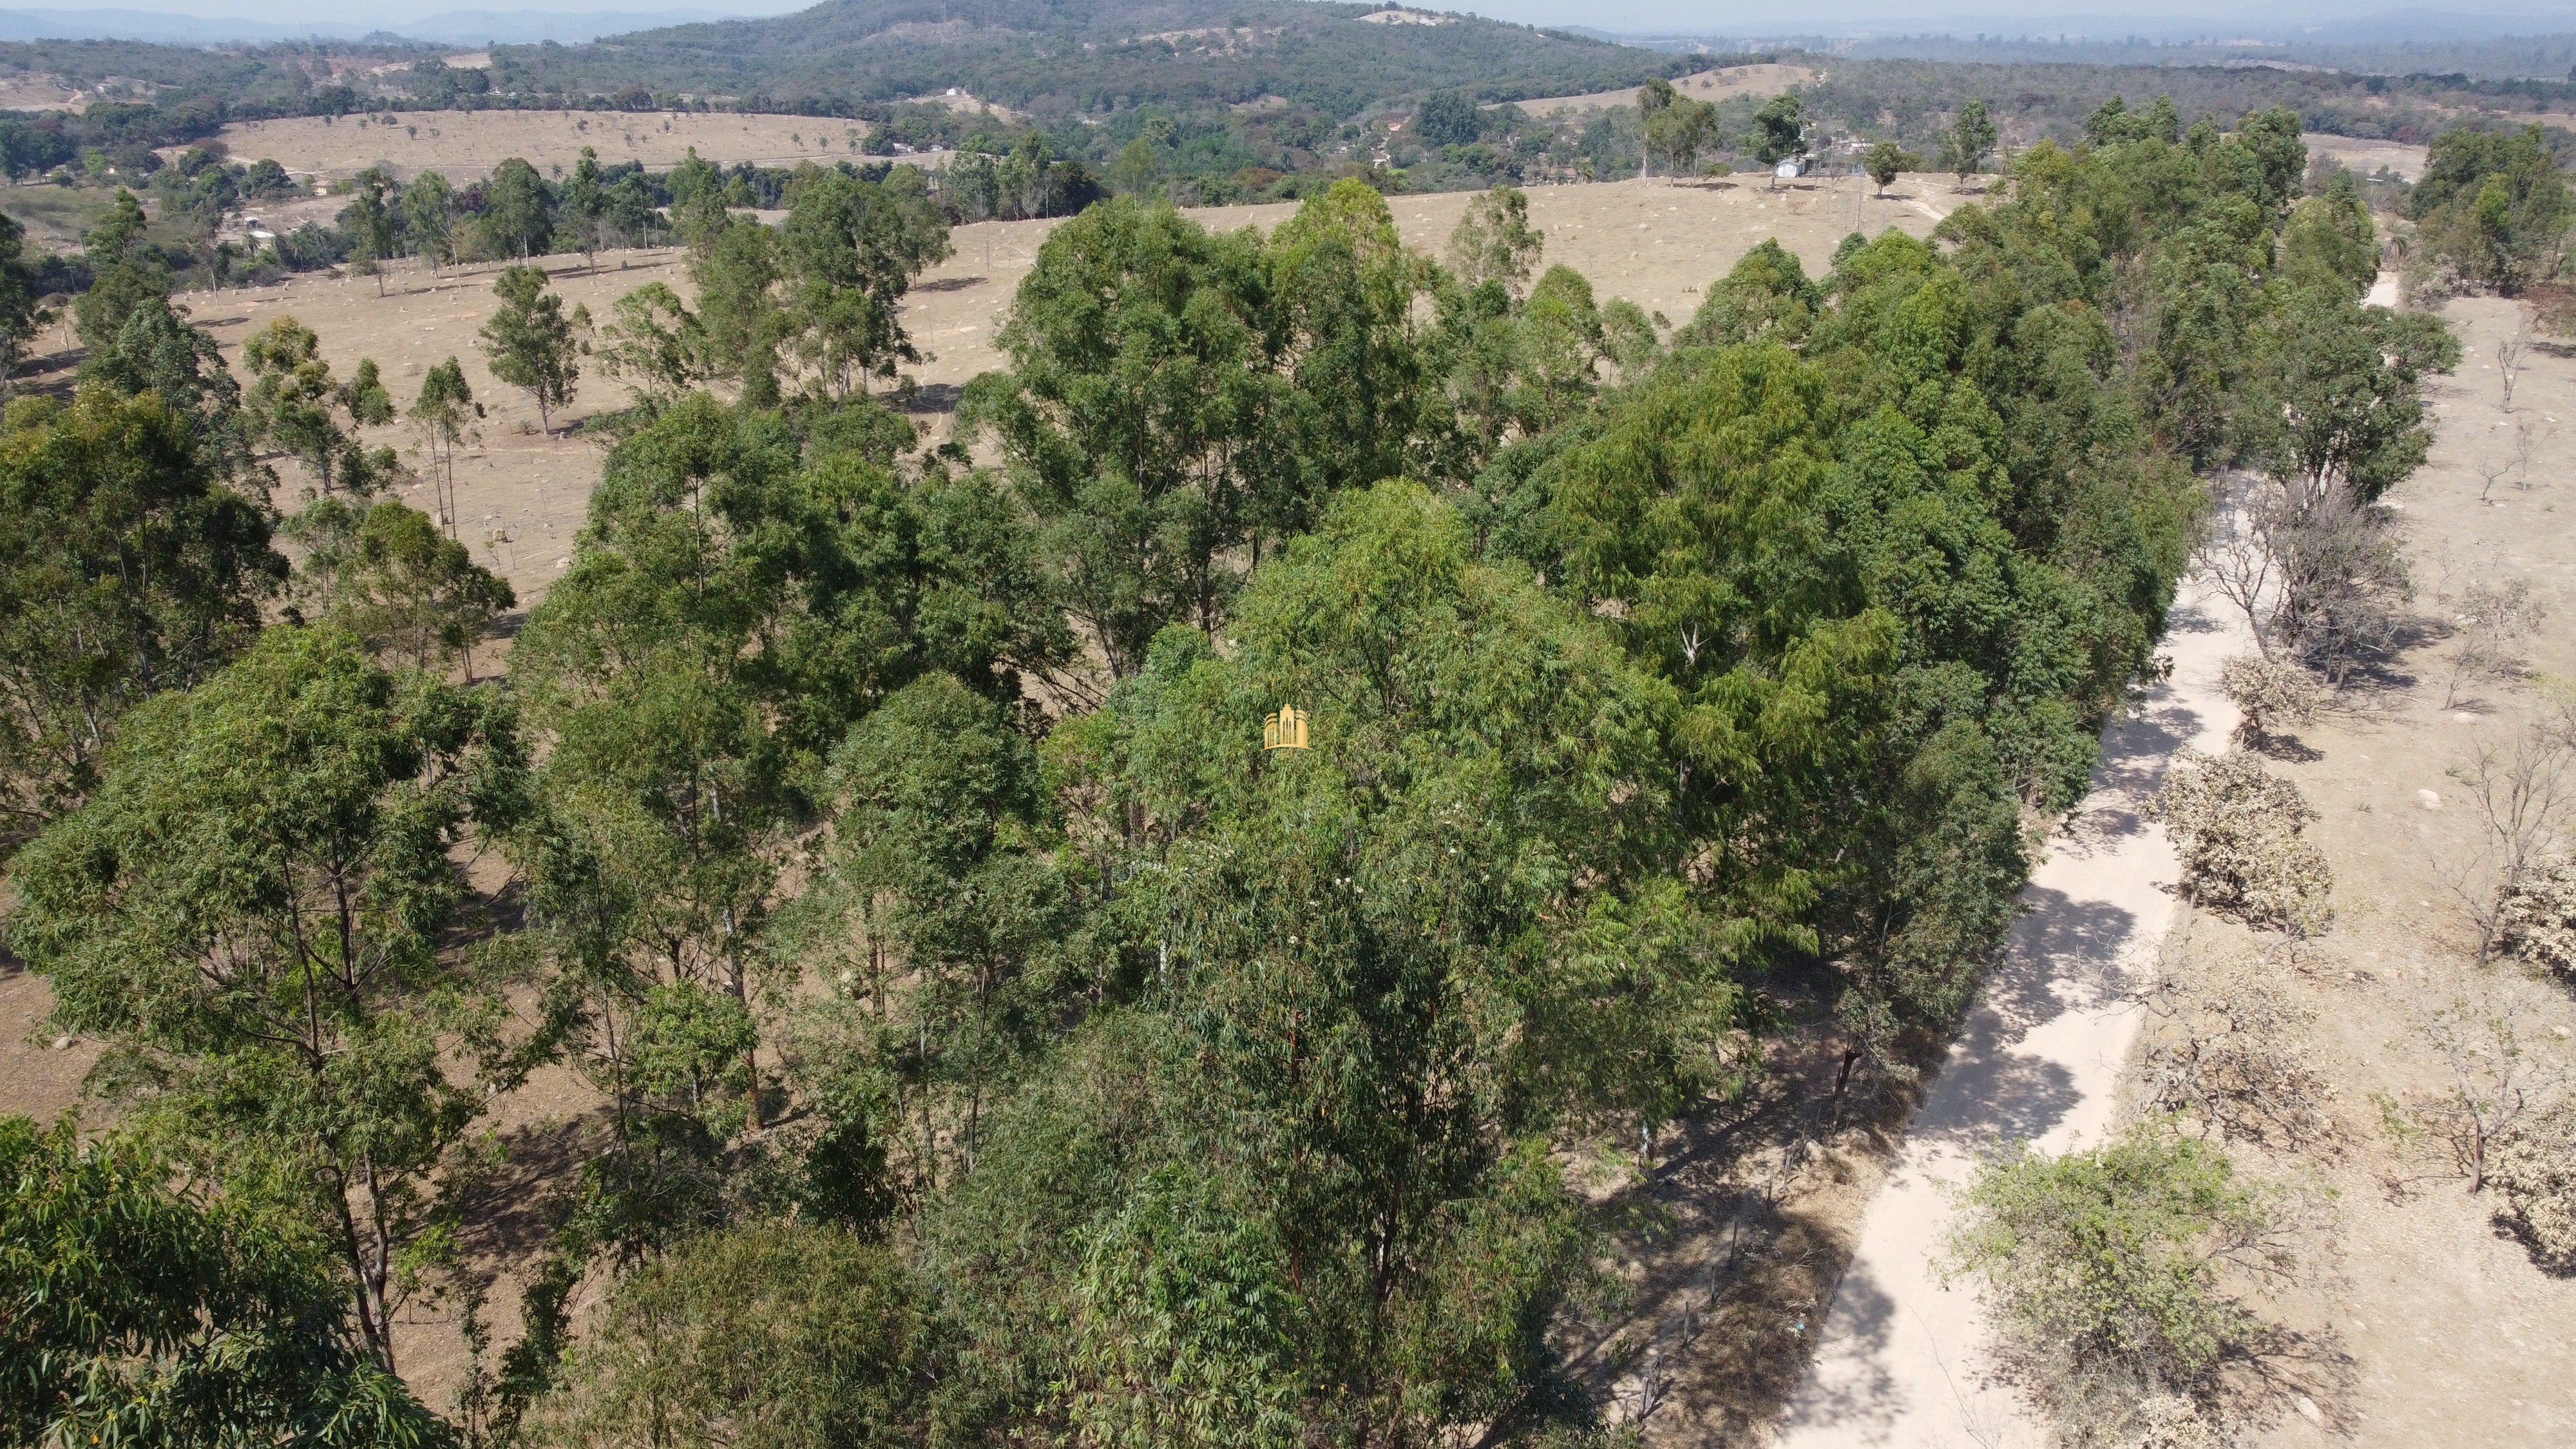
[2146,749,2334,937]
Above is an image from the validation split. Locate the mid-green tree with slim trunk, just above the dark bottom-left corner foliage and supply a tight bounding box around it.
[8,625,520,1369]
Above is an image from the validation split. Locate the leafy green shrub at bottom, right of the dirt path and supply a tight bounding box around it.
[1945,1124,2290,1441]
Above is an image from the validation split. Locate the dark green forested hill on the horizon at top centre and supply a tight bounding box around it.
[495,0,1695,116]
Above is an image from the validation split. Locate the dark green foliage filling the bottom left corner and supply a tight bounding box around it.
[0,1117,453,1449]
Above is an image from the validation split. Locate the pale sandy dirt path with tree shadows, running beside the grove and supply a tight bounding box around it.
[1780,579,2251,1449]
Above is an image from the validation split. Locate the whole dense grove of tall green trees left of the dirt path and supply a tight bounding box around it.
[0,84,2483,1446]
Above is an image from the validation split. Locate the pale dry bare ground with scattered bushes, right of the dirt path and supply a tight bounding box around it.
[2202,299,2576,1446]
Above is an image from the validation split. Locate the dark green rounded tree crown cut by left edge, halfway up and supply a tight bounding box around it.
[0,386,286,844]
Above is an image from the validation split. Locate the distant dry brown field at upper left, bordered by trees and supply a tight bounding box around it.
[186,111,891,185]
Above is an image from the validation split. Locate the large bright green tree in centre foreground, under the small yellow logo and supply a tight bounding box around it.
[1025,484,1690,1439]
